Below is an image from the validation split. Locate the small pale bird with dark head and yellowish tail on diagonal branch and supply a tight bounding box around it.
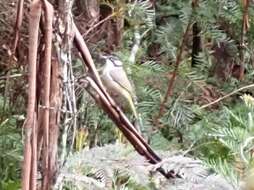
[95,55,140,132]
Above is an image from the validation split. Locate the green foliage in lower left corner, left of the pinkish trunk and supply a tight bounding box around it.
[0,97,22,190]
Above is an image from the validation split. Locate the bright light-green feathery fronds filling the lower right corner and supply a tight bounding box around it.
[188,95,254,187]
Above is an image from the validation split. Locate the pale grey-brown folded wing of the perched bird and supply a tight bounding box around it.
[109,67,134,96]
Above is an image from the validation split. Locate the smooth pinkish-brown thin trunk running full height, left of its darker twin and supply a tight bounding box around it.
[22,0,41,190]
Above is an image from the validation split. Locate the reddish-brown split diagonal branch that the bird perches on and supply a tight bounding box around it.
[74,23,170,178]
